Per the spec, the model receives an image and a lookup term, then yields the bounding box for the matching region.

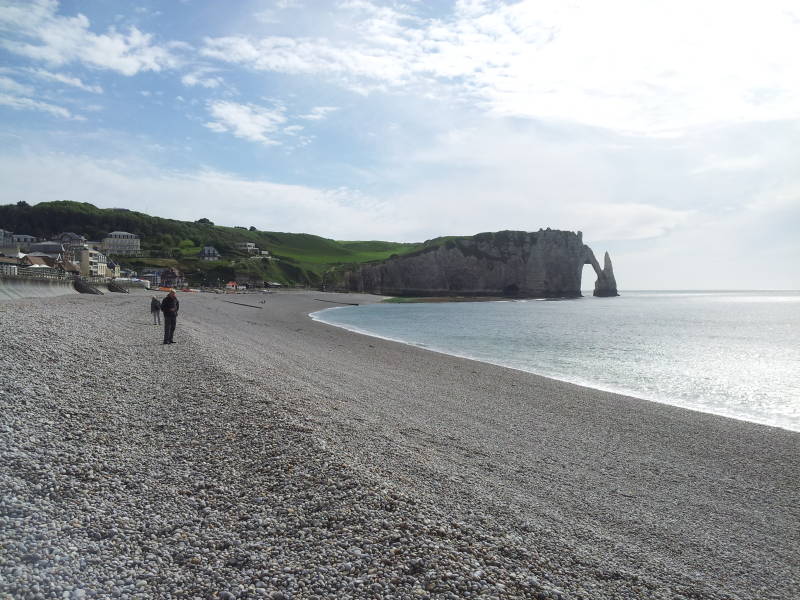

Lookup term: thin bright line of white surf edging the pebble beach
[308,300,800,433]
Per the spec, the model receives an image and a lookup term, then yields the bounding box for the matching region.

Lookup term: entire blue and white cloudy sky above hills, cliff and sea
[0,0,800,291]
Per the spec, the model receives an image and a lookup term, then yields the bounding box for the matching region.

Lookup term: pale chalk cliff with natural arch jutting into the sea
[344,229,617,298]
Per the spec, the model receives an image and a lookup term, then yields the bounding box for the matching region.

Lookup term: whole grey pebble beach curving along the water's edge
[0,292,800,600]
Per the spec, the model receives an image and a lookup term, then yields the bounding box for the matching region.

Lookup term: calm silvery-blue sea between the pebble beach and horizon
[312,292,800,431]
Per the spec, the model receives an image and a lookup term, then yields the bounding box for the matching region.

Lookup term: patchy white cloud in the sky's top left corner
[0,0,178,75]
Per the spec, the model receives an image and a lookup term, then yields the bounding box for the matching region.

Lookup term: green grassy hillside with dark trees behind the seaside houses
[0,200,422,285]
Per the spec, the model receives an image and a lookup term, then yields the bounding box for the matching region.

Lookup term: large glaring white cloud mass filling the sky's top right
[201,0,800,135]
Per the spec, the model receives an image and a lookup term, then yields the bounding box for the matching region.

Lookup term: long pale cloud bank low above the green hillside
[0,153,403,239]
